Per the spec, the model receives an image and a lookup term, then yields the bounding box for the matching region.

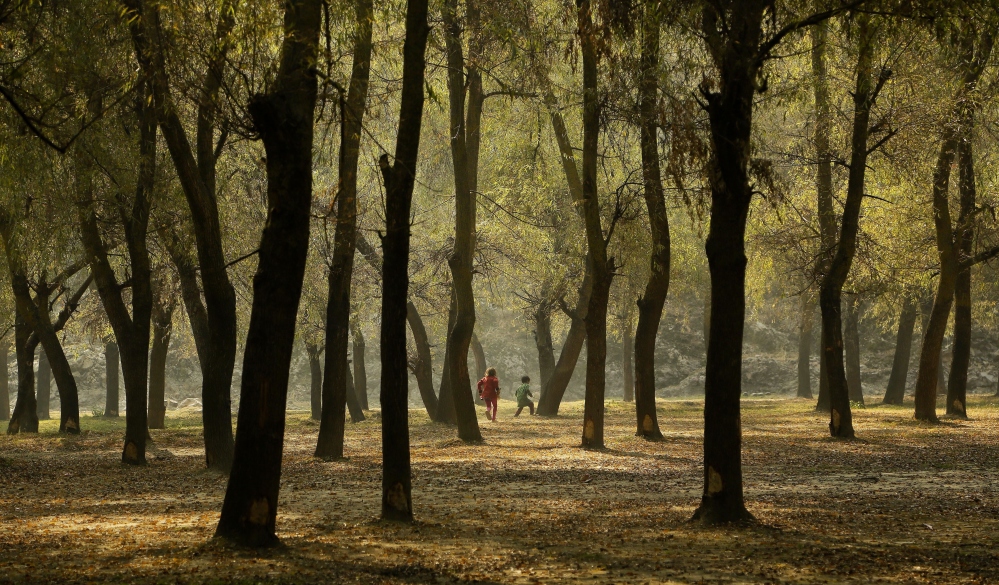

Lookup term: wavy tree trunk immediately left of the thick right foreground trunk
[629,2,672,440]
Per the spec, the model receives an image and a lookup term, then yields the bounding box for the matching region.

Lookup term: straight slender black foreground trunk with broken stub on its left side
[379,0,430,522]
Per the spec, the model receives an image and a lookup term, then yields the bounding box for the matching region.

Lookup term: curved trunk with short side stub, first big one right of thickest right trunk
[819,14,887,438]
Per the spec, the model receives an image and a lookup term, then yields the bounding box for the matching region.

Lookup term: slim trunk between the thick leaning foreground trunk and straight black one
[315,0,374,459]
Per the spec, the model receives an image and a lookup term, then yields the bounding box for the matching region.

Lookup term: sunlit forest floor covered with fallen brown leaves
[0,397,999,583]
